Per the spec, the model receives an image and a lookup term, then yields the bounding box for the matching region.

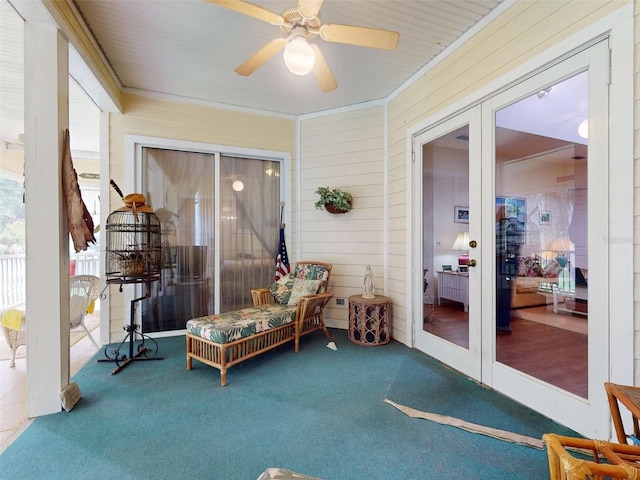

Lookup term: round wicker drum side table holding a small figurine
[349,295,391,347]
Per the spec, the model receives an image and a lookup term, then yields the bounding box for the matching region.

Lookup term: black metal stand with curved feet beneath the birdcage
[98,289,163,375]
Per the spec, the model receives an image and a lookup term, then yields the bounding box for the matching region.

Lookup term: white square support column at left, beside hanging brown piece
[24,19,69,417]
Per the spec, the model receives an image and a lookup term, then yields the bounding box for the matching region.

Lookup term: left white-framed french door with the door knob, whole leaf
[413,107,482,380]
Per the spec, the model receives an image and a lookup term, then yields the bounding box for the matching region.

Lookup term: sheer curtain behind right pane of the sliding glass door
[219,156,280,312]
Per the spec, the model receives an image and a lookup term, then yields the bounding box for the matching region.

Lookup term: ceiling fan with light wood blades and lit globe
[206,0,400,92]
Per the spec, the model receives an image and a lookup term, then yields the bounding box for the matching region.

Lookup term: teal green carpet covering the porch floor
[0,330,575,480]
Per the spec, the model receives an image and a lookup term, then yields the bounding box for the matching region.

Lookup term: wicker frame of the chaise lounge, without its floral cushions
[187,261,333,387]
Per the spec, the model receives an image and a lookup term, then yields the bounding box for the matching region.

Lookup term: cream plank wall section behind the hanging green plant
[298,106,385,328]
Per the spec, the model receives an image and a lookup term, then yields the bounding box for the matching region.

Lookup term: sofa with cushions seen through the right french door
[511,256,562,308]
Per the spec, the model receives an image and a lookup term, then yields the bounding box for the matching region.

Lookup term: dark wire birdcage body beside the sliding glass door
[105,208,162,284]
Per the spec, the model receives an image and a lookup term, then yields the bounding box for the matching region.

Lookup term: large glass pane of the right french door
[495,72,588,398]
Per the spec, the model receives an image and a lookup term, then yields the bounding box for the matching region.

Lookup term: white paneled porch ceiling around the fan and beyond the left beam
[0,0,501,154]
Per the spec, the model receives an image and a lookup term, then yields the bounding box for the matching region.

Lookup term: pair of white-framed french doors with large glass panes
[414,41,609,438]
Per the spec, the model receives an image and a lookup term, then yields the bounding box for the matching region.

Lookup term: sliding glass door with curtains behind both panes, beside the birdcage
[142,147,281,333]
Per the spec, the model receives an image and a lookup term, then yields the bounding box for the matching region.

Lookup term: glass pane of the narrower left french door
[422,126,469,349]
